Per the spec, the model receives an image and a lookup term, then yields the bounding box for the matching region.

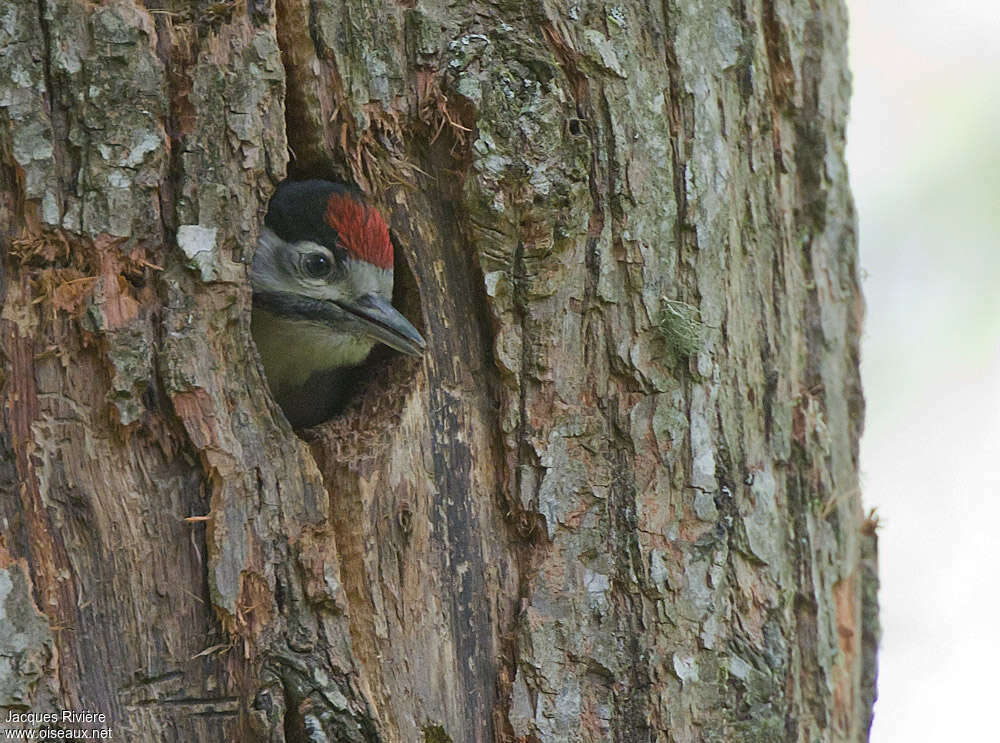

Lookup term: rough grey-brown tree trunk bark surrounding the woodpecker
[0,0,877,743]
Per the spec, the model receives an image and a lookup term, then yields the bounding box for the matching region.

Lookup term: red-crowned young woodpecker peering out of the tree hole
[250,180,426,428]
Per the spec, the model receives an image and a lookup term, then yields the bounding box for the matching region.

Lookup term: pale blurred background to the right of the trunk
[848,0,1000,743]
